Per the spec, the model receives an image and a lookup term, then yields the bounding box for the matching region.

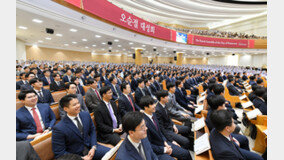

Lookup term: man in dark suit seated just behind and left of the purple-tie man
[85,80,102,113]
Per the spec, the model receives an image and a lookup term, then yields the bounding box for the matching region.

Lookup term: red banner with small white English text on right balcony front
[193,35,248,48]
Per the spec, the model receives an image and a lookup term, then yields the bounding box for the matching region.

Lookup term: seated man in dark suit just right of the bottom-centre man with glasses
[141,96,192,160]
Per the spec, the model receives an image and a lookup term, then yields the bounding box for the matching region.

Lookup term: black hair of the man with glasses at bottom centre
[122,111,144,134]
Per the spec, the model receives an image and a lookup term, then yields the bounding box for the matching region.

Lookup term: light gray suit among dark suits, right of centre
[166,93,192,121]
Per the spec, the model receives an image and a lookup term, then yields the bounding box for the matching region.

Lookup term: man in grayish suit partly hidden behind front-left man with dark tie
[58,82,89,119]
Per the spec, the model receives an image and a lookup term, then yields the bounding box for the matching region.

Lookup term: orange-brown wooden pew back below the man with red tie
[30,132,54,160]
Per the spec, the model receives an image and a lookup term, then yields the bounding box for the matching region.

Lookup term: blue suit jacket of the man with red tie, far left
[16,104,56,141]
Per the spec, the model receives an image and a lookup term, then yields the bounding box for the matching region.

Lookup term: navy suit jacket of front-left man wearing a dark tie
[51,112,98,158]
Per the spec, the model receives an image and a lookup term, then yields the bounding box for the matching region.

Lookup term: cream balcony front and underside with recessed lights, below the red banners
[16,0,267,57]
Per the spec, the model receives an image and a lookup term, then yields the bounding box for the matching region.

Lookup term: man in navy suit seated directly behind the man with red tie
[30,78,54,104]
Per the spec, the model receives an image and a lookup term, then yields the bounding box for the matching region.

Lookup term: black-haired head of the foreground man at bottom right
[209,110,233,132]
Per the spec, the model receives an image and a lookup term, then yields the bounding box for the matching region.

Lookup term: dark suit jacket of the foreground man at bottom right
[209,129,245,160]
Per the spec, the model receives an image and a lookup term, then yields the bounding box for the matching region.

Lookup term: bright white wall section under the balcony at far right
[208,54,267,67]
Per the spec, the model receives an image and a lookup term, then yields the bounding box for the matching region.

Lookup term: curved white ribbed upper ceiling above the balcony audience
[108,0,267,28]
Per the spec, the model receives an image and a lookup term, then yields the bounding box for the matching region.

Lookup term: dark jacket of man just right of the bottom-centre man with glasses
[144,113,167,154]
